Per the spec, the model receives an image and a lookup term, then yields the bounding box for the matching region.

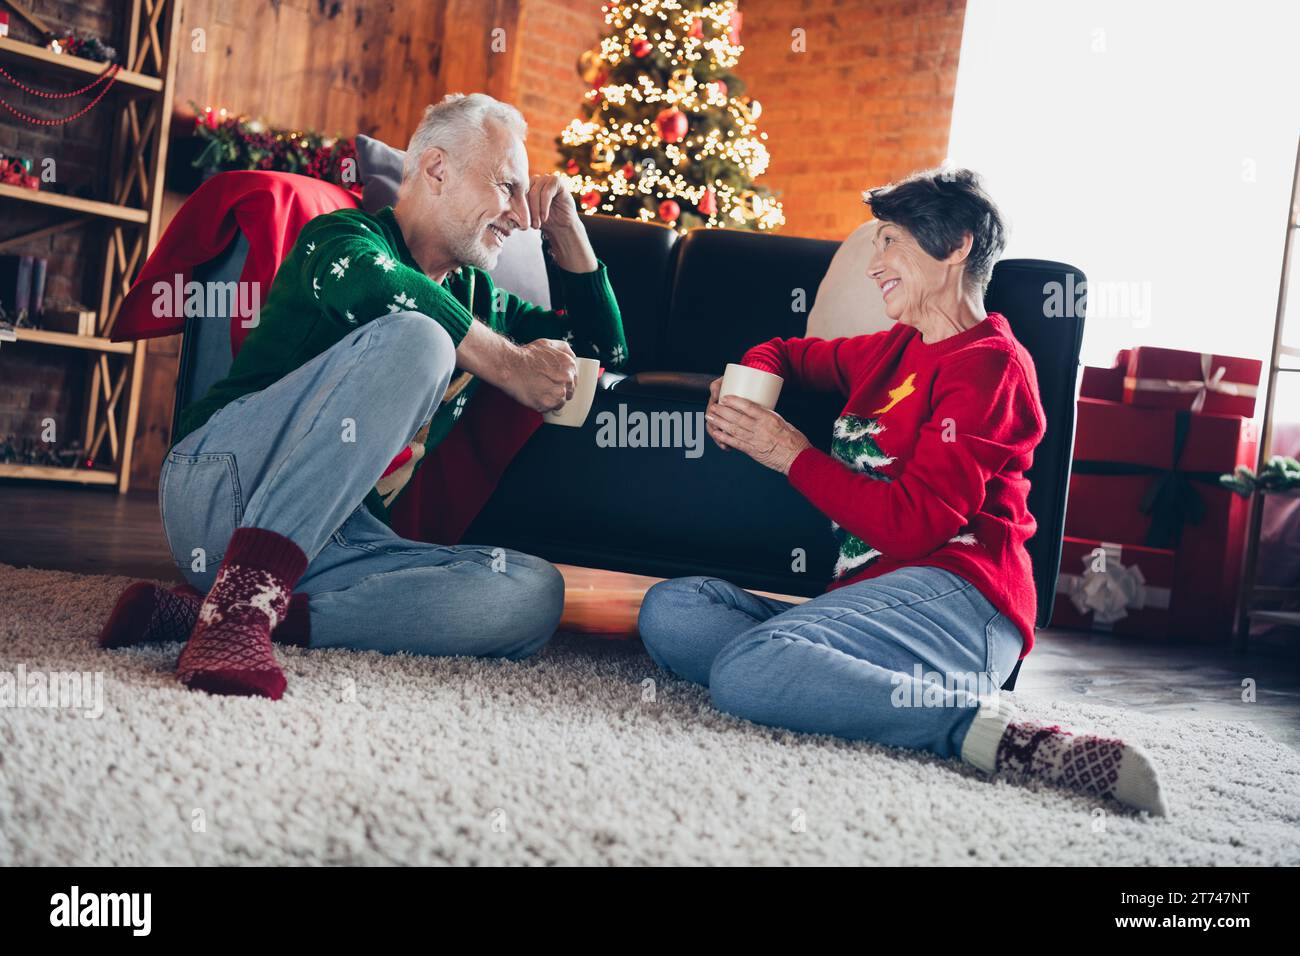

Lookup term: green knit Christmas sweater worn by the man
[172,207,628,522]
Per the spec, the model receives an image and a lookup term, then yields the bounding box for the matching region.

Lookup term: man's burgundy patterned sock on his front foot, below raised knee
[177,528,307,700]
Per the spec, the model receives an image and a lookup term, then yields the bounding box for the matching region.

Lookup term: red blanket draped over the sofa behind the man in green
[113,172,542,544]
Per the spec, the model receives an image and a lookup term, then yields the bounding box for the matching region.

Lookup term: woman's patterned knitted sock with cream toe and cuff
[962,701,1169,817]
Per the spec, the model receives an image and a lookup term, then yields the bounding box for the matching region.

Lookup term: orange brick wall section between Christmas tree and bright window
[737,0,966,239]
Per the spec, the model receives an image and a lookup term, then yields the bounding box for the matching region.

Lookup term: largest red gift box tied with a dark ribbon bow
[1065,398,1258,640]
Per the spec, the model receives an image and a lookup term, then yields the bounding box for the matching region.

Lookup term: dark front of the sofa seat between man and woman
[464,376,844,597]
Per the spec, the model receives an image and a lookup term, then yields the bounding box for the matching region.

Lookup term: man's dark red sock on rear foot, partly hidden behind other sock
[99,581,311,649]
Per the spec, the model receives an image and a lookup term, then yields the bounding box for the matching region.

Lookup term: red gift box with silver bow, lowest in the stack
[1052,537,1174,636]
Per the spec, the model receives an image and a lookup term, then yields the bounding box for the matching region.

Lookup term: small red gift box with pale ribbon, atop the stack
[1125,346,1264,418]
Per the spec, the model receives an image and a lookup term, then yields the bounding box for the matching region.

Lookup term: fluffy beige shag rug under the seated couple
[0,564,1300,866]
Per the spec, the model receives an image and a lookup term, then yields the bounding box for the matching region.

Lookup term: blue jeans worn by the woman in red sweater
[638,567,1024,757]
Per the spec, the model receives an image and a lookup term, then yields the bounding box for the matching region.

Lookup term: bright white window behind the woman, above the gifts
[949,0,1300,392]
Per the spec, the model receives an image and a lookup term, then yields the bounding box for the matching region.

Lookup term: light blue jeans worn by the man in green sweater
[159,312,564,659]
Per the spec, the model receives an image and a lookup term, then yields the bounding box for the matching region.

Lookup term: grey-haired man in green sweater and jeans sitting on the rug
[100,94,627,698]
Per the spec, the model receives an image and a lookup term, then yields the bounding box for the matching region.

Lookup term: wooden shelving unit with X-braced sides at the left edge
[0,0,182,492]
